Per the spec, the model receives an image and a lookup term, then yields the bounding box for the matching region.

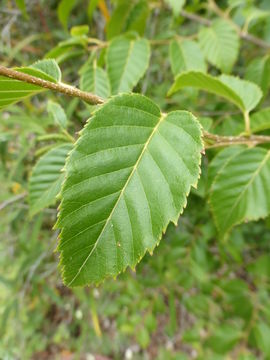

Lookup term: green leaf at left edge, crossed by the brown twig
[0,60,61,110]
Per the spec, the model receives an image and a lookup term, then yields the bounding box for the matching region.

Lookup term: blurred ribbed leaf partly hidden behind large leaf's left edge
[29,144,72,216]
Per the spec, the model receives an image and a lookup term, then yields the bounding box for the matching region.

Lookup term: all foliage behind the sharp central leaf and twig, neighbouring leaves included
[0,0,270,360]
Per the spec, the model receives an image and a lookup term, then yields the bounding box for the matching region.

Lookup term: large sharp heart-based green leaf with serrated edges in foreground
[56,94,202,286]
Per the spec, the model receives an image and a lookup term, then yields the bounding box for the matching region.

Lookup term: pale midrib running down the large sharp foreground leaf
[67,114,166,286]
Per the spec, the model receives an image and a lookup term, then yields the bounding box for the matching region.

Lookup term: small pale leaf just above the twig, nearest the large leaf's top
[80,62,111,99]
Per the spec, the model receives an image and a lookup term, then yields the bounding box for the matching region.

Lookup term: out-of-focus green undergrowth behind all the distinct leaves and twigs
[0,0,270,360]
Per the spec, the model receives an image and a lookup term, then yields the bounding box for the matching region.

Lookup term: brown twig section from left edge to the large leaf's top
[0,65,104,105]
